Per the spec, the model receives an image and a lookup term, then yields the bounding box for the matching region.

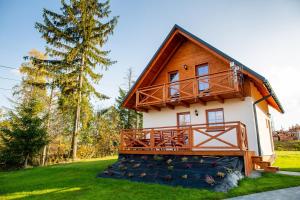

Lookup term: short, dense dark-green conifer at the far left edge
[0,98,48,168]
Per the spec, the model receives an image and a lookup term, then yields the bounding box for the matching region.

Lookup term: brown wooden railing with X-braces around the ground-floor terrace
[120,121,248,151]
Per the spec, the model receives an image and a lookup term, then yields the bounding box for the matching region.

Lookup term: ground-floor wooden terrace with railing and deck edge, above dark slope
[120,121,248,155]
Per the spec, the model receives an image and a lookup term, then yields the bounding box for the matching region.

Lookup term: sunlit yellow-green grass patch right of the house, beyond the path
[273,151,300,172]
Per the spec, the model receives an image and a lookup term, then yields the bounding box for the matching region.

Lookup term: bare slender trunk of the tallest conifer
[71,57,84,160]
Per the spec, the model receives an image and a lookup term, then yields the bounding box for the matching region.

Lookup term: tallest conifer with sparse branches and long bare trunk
[36,0,117,159]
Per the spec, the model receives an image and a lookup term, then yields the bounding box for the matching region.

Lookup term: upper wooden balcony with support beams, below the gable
[136,70,243,110]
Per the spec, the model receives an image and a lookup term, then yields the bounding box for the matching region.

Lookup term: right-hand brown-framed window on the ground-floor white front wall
[206,108,224,129]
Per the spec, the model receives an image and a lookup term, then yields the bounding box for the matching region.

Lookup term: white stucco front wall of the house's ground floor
[143,97,258,152]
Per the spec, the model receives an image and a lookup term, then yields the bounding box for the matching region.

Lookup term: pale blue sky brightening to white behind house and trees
[0,0,300,128]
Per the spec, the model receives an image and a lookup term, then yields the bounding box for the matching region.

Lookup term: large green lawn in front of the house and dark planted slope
[0,154,300,200]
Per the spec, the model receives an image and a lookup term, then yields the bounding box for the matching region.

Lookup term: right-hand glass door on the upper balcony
[196,64,209,93]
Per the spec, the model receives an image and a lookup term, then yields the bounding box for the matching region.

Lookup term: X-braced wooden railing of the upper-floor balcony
[136,70,242,107]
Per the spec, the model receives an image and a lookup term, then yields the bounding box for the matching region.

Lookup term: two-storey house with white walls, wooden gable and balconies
[102,25,284,188]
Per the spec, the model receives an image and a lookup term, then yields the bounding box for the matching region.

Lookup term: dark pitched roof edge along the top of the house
[122,24,284,113]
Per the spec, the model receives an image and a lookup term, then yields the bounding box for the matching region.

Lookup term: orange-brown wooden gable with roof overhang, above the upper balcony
[122,25,284,112]
